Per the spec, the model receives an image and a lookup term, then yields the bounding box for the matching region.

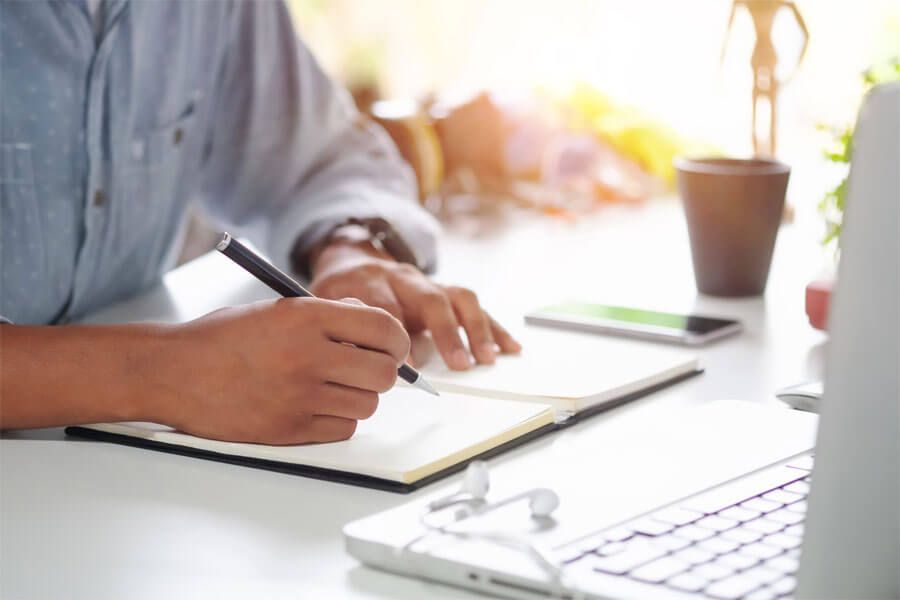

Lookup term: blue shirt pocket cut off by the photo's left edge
[0,144,46,322]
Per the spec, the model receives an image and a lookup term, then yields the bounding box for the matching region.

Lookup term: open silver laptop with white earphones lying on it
[344,83,900,600]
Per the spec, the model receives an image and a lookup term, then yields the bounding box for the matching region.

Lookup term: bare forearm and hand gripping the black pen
[0,298,409,444]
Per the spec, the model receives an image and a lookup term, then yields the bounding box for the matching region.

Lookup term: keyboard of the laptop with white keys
[556,456,812,600]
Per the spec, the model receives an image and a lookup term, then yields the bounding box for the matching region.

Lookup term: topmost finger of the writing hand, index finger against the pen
[317,300,410,366]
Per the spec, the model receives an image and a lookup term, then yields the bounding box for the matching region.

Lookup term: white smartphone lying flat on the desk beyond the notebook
[525,302,741,346]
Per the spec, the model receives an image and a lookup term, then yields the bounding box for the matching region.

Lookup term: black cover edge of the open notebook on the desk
[66,370,703,494]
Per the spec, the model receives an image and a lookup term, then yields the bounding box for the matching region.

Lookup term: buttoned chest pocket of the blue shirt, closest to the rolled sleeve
[118,105,196,284]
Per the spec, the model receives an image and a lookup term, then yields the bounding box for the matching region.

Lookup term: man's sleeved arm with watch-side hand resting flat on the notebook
[197,2,519,369]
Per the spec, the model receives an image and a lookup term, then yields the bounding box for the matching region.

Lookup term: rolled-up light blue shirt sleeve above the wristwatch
[200,0,437,271]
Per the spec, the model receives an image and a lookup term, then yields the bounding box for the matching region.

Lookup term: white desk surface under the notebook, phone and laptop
[0,203,826,600]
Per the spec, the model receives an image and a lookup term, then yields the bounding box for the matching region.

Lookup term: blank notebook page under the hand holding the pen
[89,385,553,483]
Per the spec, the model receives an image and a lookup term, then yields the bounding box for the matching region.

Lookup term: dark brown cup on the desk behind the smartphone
[675,158,791,296]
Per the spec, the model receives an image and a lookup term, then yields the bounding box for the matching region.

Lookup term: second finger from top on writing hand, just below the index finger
[322,343,398,392]
